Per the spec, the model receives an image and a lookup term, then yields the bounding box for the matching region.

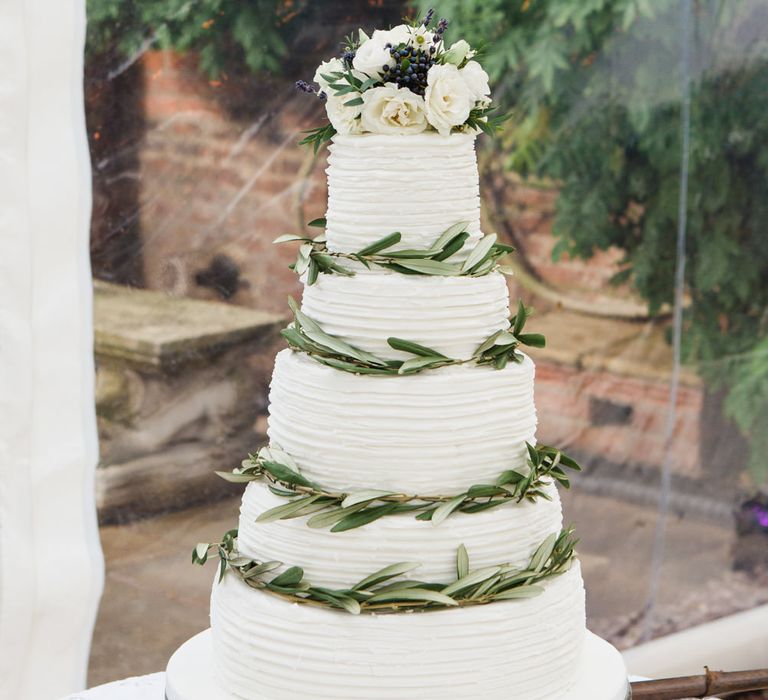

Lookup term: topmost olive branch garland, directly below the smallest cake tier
[273,219,515,285]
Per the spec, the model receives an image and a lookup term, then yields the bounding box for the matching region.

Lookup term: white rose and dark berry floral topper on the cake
[296,10,504,149]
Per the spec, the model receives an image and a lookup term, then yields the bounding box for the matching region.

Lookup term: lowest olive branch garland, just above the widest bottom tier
[192,528,578,615]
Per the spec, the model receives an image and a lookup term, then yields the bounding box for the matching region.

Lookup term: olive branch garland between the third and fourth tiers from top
[216,443,581,532]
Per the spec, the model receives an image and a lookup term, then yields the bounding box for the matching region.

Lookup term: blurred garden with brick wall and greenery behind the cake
[85,0,768,683]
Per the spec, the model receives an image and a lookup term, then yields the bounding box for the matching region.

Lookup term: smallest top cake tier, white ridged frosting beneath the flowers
[326,133,481,253]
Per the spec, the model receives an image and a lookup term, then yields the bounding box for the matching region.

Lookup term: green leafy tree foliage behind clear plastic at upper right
[423,0,768,486]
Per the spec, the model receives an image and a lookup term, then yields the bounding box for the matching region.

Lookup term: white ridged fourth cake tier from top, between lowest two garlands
[238,482,562,588]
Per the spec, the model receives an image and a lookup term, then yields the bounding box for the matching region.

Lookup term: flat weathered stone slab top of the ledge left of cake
[94,282,286,370]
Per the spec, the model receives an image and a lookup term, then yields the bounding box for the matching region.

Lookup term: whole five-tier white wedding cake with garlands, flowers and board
[167,13,628,700]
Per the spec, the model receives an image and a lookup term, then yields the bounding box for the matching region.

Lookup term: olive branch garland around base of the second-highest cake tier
[281,297,546,376]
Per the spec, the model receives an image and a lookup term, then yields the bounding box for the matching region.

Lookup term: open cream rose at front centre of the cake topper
[361,83,427,134]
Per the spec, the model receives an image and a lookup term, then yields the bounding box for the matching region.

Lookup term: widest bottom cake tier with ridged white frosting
[195,562,626,700]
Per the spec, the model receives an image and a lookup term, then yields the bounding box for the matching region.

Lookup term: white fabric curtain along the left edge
[0,0,103,700]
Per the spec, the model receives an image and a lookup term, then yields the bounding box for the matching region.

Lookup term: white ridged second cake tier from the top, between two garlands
[302,272,509,359]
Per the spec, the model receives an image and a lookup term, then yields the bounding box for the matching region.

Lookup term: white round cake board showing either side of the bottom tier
[165,629,629,700]
